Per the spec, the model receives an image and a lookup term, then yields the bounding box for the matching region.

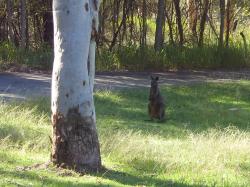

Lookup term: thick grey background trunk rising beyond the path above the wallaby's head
[154,0,166,51]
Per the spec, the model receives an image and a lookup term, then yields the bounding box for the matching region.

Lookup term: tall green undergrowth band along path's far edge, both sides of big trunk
[0,42,250,71]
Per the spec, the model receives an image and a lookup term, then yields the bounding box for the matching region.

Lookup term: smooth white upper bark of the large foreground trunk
[52,0,94,117]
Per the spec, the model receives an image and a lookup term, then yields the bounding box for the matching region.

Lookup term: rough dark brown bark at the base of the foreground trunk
[51,107,101,172]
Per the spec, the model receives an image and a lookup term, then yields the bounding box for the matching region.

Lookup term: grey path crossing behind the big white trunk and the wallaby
[0,71,250,99]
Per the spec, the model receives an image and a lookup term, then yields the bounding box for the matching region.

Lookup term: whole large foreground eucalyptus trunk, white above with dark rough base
[51,0,101,172]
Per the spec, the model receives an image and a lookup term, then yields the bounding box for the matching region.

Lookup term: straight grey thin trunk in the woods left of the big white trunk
[20,0,27,48]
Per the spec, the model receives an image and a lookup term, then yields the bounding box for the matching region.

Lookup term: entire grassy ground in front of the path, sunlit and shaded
[0,80,250,187]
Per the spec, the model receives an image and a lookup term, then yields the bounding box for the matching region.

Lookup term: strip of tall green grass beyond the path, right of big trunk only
[96,45,250,71]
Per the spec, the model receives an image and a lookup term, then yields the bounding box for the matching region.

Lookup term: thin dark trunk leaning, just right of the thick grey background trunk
[174,0,184,46]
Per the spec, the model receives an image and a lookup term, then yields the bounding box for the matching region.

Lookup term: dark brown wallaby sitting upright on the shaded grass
[148,76,165,121]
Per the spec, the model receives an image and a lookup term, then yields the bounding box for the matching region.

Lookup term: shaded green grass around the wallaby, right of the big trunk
[95,83,250,137]
